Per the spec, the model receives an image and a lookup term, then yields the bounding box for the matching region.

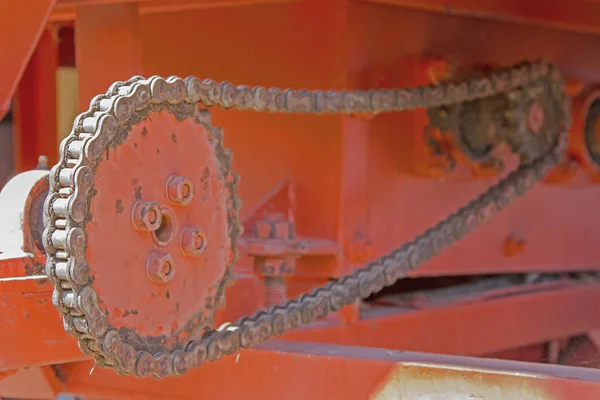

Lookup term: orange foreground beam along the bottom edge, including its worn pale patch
[54,341,600,400]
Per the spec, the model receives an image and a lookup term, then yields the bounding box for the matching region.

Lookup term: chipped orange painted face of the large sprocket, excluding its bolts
[86,111,231,340]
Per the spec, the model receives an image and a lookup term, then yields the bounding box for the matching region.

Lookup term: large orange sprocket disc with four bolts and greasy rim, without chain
[85,107,237,353]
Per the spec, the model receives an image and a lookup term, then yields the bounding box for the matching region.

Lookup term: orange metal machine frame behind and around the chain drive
[0,0,600,399]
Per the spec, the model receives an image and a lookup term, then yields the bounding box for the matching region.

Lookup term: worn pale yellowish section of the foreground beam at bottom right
[369,346,600,400]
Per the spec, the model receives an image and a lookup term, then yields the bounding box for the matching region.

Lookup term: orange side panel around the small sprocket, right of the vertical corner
[360,5,600,276]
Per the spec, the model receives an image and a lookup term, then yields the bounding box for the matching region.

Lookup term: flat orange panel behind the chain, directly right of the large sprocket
[133,2,345,253]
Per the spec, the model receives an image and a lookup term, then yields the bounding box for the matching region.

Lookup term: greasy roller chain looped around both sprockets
[44,61,570,378]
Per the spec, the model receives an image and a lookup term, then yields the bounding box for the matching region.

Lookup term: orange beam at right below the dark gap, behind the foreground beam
[283,283,600,356]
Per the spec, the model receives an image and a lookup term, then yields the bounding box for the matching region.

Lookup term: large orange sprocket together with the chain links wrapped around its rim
[43,77,241,377]
